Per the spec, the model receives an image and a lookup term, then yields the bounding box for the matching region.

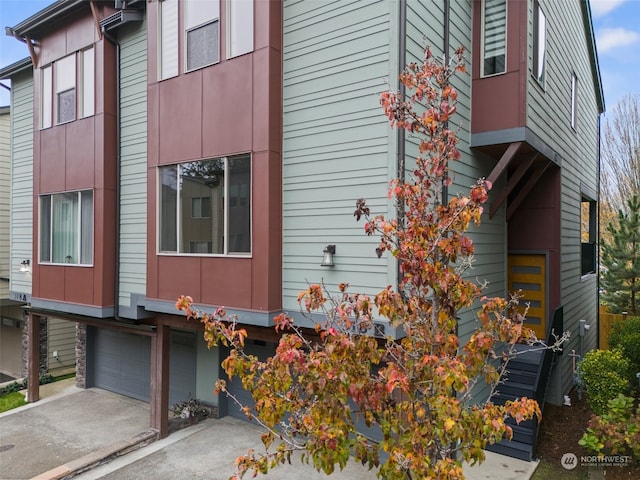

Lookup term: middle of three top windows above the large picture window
[184,0,220,71]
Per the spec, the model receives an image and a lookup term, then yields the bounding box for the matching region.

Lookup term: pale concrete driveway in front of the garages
[0,379,537,480]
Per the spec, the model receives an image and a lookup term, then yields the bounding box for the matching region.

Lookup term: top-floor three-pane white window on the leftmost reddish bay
[40,47,95,128]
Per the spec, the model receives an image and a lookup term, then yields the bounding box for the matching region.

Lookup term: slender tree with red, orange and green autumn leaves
[177,50,540,480]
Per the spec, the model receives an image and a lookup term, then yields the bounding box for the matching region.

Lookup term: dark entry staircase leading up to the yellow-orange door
[487,306,563,461]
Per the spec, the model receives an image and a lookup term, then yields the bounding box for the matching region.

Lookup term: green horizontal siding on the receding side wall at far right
[527,0,598,402]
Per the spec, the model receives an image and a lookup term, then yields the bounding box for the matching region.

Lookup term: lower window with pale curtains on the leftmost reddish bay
[40,190,93,265]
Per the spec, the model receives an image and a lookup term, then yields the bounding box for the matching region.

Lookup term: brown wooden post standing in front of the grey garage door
[150,325,171,438]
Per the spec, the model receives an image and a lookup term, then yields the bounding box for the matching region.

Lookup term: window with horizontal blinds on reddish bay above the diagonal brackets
[482,0,507,76]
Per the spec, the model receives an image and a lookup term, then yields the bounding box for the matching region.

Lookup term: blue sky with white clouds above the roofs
[0,0,640,111]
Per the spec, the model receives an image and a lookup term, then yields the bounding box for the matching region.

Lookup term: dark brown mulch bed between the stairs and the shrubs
[538,390,640,480]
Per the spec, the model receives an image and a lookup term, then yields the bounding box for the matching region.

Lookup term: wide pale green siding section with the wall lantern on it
[282,0,397,311]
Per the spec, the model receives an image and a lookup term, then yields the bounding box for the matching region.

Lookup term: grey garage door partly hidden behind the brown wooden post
[88,328,196,405]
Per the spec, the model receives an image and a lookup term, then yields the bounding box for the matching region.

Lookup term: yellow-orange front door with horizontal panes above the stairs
[507,254,547,340]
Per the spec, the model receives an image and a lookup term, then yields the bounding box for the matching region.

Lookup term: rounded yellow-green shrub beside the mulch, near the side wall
[578,350,631,415]
